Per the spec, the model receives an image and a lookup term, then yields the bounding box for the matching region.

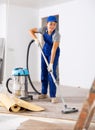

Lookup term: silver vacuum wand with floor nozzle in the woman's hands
[35,39,78,114]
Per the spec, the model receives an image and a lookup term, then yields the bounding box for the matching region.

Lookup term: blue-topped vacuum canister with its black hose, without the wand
[6,40,41,100]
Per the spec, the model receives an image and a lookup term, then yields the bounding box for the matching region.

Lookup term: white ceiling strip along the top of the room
[0,0,72,9]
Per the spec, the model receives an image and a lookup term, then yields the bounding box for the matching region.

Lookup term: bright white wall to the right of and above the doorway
[39,0,95,88]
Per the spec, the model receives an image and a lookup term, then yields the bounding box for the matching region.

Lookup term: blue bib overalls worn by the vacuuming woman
[41,31,60,97]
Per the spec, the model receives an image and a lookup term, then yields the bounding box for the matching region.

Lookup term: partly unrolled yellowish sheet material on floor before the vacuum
[0,94,45,112]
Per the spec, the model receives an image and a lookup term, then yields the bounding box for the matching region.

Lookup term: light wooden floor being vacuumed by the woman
[0,83,95,130]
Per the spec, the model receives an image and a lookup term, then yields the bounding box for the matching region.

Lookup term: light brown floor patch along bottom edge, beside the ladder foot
[17,120,95,130]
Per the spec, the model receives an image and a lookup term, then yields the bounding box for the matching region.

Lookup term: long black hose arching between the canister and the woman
[26,40,41,94]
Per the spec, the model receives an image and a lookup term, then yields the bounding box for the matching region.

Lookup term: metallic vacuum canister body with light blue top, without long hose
[6,68,33,100]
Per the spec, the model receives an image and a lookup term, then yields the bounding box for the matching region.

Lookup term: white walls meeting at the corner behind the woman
[3,0,95,88]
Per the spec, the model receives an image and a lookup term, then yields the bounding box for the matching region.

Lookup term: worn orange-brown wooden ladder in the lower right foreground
[74,79,95,130]
